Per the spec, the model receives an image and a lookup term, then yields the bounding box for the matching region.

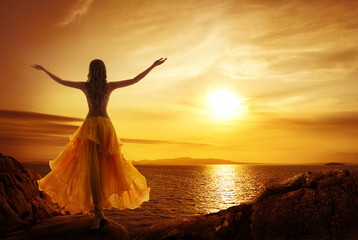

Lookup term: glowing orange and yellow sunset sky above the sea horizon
[0,0,358,164]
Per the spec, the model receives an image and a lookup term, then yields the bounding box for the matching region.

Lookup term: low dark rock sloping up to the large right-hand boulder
[137,204,251,240]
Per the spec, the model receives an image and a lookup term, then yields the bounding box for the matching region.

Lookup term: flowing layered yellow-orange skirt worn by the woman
[37,116,150,213]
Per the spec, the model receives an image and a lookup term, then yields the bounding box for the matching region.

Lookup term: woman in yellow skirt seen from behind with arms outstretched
[32,58,167,229]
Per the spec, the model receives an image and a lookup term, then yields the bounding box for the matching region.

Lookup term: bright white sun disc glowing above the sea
[207,89,245,120]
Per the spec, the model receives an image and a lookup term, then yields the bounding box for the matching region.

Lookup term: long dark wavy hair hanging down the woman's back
[86,59,107,107]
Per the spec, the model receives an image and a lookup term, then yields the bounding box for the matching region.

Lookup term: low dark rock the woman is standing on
[7,215,129,240]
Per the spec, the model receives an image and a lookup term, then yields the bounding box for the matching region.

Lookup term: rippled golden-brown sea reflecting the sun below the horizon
[24,164,358,238]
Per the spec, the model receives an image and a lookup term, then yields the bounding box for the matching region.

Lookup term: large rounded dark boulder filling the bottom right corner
[251,170,358,239]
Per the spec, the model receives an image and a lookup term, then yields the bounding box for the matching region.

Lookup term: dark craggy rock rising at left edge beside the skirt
[0,154,60,236]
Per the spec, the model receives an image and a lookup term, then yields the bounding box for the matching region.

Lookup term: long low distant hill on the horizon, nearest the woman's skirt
[133,157,251,165]
